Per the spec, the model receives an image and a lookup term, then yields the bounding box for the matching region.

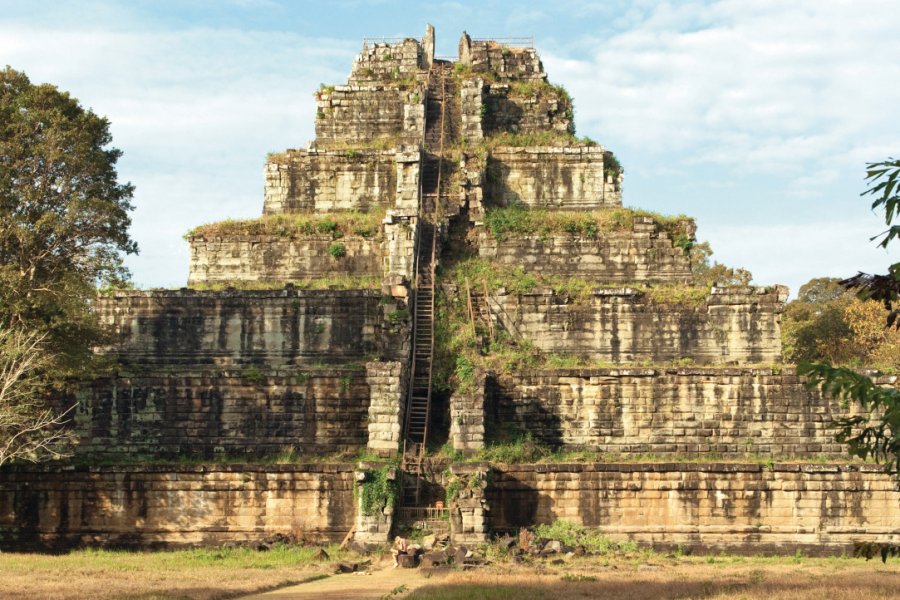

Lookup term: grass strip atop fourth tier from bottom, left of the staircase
[184,211,384,240]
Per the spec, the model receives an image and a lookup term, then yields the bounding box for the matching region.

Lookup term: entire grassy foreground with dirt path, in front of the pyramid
[0,550,900,600]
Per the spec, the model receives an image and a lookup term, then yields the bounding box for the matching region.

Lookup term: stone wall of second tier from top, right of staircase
[482,83,575,135]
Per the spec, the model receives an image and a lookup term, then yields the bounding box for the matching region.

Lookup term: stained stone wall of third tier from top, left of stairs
[263,149,397,215]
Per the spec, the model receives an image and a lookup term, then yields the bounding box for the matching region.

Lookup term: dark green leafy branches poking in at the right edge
[798,158,900,474]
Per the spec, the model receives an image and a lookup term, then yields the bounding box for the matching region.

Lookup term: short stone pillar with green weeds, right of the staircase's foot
[447,463,492,544]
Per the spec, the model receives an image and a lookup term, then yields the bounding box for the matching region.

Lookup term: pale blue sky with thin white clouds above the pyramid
[0,0,900,291]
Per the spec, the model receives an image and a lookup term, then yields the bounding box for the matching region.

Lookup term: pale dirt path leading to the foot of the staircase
[243,568,433,600]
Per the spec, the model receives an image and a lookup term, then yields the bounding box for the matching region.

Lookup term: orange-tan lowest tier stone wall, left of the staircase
[0,464,355,551]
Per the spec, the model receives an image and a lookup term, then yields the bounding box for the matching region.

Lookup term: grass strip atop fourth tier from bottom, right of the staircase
[484,206,693,242]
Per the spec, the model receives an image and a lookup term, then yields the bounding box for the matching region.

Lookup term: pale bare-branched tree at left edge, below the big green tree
[0,327,74,465]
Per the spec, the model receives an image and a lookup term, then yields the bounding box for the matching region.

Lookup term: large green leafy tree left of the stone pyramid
[0,67,137,375]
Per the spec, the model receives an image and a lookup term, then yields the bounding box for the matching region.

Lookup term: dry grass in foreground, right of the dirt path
[406,558,900,600]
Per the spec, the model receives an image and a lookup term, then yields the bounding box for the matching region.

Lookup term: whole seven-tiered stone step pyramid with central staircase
[0,27,900,552]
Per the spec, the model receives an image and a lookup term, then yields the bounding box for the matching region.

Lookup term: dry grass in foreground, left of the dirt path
[0,546,358,600]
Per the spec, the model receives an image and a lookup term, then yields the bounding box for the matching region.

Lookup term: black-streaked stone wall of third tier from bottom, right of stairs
[490,286,787,364]
